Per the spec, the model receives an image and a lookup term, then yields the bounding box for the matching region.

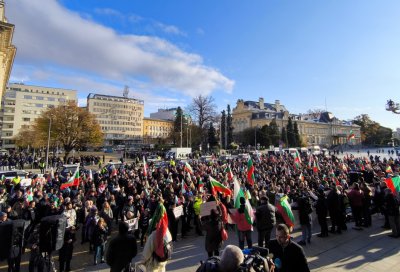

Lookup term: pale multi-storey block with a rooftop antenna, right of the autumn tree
[87,93,144,145]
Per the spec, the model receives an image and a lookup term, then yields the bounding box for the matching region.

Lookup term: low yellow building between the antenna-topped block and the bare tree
[143,117,174,143]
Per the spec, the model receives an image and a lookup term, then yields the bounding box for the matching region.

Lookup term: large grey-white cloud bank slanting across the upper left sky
[6,0,234,97]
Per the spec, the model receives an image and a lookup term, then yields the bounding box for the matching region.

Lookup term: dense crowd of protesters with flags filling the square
[0,149,400,272]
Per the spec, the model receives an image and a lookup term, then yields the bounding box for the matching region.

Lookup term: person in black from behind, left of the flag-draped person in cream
[106,222,137,272]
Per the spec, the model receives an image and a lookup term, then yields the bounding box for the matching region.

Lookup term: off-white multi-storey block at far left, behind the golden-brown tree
[0,84,77,148]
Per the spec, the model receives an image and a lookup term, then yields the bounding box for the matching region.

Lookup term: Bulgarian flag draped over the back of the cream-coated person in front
[147,203,168,258]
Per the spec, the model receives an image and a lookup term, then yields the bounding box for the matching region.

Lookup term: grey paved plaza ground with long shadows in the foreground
[0,212,400,272]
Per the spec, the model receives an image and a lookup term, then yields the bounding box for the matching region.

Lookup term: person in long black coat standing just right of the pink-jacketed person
[256,196,276,247]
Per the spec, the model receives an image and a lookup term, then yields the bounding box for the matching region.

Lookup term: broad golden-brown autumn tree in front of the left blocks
[17,101,103,160]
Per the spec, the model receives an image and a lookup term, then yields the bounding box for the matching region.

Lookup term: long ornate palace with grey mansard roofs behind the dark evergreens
[232,98,361,147]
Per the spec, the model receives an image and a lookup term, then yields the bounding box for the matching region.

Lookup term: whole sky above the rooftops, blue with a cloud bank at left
[5,0,400,129]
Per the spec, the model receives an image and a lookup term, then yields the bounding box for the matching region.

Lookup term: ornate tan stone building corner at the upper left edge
[0,0,17,104]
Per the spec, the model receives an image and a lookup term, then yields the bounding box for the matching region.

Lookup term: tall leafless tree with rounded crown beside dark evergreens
[189,95,216,128]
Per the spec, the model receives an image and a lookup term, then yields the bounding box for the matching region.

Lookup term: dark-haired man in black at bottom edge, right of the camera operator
[268,224,310,272]
